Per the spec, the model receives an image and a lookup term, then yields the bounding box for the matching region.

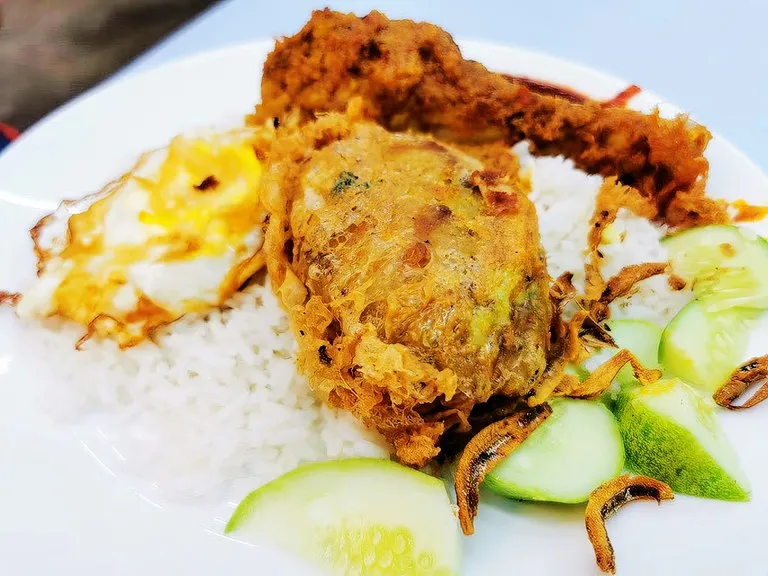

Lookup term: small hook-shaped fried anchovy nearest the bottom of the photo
[585,474,674,574]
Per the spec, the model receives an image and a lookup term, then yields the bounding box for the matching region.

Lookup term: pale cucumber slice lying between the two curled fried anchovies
[485,398,624,503]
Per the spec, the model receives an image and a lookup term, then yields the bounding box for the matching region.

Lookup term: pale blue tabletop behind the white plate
[126,0,768,170]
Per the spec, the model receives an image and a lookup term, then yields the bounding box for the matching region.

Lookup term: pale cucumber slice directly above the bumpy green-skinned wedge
[659,300,760,393]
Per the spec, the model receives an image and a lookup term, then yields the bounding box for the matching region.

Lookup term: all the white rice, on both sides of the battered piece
[28,145,690,508]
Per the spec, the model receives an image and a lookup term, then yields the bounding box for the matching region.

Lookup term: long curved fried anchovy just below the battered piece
[455,404,552,536]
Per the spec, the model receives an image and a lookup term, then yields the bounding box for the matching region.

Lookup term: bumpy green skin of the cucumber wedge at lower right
[615,392,750,502]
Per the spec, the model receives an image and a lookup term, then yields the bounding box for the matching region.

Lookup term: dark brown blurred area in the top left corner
[0,0,220,129]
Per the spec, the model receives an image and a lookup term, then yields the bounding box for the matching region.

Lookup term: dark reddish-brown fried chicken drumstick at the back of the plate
[253,9,728,226]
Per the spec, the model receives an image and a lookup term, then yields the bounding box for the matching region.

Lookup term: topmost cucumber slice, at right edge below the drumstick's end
[663,226,768,311]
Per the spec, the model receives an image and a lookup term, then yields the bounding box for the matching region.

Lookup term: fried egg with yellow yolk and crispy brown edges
[16,128,271,347]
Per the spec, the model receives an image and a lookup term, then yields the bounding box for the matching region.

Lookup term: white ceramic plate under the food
[0,42,768,576]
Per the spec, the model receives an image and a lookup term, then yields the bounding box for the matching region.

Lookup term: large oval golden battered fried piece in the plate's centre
[263,114,553,466]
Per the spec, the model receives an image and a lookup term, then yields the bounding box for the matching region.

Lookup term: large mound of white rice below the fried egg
[37,285,388,500]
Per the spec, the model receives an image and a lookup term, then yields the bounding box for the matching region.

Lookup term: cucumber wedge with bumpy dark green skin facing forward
[616,379,749,501]
